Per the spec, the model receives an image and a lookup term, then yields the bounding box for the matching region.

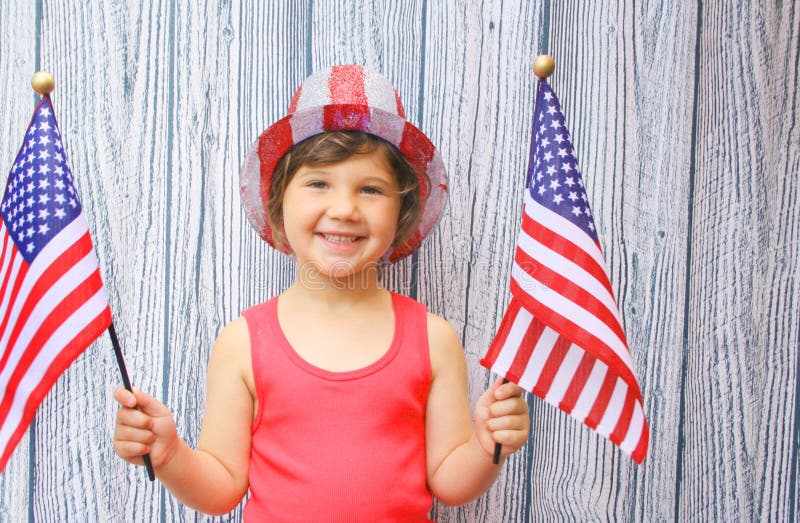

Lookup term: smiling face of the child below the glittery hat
[283,150,401,283]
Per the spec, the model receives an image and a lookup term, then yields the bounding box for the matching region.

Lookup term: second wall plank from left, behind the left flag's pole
[27,2,175,521]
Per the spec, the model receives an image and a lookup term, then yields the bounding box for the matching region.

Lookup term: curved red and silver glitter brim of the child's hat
[239,105,448,262]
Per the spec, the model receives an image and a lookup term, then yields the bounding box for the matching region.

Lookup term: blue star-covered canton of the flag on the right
[527,82,598,246]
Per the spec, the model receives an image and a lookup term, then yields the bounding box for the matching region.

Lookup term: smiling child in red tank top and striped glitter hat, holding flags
[114,66,529,521]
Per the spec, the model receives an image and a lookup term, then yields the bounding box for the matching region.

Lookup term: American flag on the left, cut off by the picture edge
[0,96,111,471]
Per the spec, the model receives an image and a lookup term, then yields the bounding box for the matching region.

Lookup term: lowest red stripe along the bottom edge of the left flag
[0,307,111,470]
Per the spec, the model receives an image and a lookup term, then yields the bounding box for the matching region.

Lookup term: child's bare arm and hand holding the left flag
[114,318,254,514]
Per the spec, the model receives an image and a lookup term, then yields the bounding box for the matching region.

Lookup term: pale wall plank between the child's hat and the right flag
[419,1,542,521]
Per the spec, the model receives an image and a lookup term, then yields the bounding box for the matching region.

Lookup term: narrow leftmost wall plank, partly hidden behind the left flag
[0,2,37,521]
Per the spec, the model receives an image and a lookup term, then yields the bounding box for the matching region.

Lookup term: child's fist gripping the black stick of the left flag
[114,388,180,469]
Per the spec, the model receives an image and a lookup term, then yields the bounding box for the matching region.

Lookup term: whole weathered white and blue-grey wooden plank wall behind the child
[0,0,800,521]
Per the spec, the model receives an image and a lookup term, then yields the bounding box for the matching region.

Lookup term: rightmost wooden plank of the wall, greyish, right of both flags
[679,3,799,520]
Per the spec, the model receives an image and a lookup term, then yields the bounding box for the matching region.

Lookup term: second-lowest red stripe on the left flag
[0,270,103,425]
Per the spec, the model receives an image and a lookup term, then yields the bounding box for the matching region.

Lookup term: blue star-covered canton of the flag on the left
[0,99,81,263]
